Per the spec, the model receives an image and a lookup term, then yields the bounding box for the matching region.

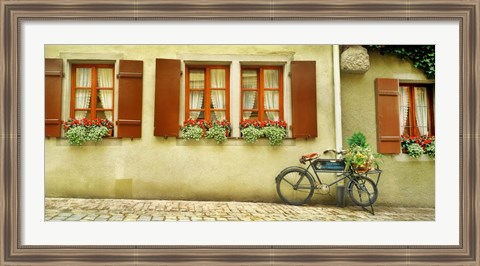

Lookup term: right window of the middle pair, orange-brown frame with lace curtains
[241,66,283,121]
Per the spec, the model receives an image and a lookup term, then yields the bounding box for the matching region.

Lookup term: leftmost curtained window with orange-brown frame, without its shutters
[70,65,114,121]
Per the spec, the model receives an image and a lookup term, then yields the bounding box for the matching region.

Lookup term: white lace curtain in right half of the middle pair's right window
[263,69,280,120]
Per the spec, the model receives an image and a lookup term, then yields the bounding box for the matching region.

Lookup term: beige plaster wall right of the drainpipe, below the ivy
[341,53,435,207]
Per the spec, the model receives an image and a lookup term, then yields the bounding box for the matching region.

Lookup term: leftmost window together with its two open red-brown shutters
[45,59,143,139]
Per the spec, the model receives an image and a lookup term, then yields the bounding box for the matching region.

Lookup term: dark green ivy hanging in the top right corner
[364,45,435,79]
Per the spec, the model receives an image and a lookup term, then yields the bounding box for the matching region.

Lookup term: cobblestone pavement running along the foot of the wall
[45,198,435,221]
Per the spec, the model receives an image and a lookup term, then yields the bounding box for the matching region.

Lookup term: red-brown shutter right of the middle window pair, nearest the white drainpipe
[291,61,317,138]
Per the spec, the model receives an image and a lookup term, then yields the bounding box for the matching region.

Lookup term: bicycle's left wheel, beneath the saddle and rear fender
[277,168,314,205]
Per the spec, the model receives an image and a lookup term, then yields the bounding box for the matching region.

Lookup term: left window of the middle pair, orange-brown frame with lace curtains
[185,66,230,121]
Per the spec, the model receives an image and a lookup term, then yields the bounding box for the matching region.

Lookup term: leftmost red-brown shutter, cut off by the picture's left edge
[45,59,63,137]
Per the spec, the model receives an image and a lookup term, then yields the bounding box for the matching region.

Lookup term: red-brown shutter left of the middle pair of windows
[153,59,181,137]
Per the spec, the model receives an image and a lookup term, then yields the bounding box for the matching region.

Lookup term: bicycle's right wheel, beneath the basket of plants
[347,176,378,207]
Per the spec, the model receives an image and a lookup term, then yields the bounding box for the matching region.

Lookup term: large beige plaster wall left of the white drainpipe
[45,45,335,203]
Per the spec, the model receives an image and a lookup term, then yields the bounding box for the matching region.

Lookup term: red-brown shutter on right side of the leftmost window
[117,60,143,138]
